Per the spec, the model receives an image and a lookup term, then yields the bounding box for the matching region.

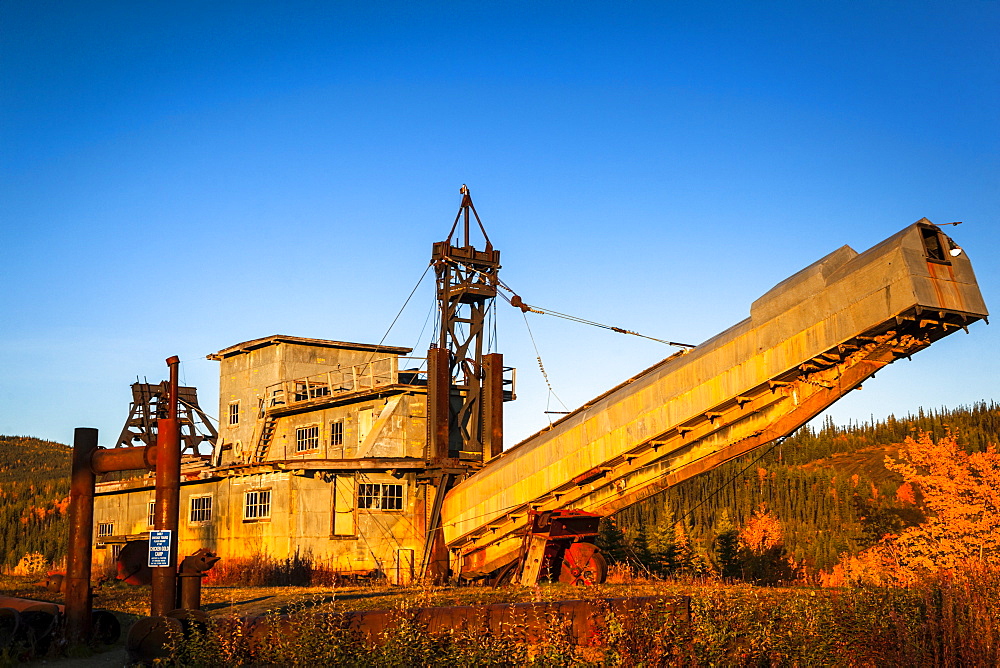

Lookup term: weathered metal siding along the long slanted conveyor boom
[443,221,986,568]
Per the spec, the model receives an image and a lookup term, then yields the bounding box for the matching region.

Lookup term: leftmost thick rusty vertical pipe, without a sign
[65,427,97,645]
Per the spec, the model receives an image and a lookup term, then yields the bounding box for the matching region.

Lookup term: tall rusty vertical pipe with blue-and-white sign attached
[149,356,181,617]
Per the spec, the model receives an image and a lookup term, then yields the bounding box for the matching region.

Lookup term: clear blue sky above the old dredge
[0,0,1000,443]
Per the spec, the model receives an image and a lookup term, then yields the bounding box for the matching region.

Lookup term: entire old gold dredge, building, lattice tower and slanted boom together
[88,188,987,584]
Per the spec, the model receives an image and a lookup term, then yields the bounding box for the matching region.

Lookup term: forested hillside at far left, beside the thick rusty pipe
[0,435,72,569]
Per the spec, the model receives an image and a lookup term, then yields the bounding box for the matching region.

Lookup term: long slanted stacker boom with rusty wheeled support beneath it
[441,219,987,584]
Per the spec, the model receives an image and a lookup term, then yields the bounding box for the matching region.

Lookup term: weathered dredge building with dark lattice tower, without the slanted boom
[94,187,514,584]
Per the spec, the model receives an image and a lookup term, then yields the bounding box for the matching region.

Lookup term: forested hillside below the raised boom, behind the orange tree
[603,402,1000,572]
